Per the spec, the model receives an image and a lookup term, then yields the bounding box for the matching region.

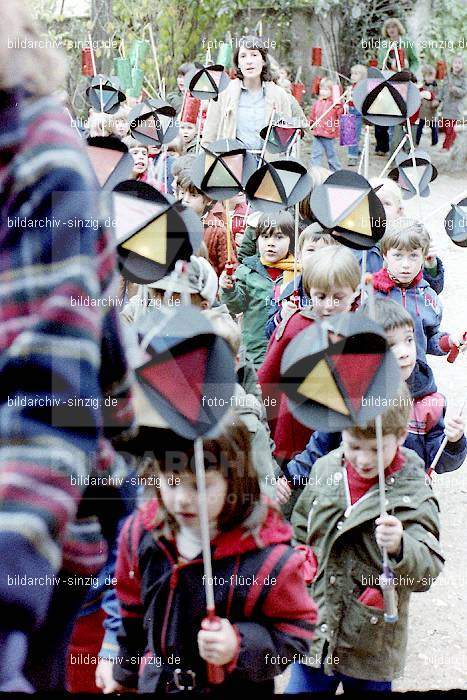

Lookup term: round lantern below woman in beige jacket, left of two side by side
[191,139,256,201]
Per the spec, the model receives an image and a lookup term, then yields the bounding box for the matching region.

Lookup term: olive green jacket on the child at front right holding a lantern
[292,447,444,681]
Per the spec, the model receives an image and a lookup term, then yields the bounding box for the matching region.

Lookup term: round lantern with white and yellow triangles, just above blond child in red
[310,170,386,250]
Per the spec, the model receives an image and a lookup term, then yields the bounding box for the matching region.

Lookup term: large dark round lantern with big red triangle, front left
[131,306,236,440]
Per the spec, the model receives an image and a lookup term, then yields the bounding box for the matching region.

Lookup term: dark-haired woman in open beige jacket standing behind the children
[202,36,307,152]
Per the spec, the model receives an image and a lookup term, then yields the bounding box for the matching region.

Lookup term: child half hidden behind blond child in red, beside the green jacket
[266,224,339,338]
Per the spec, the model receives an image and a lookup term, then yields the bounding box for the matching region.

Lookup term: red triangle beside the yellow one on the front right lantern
[330,353,384,411]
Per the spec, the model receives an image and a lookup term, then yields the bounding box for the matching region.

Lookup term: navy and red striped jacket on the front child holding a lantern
[113,501,316,692]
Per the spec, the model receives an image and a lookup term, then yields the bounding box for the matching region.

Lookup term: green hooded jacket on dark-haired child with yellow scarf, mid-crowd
[220,255,277,369]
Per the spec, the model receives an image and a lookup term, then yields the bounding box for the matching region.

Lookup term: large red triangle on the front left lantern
[138,347,208,423]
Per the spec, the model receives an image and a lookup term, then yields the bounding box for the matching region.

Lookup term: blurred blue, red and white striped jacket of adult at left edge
[0,90,133,629]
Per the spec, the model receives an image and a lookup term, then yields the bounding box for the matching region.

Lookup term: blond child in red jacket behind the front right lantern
[258,246,360,463]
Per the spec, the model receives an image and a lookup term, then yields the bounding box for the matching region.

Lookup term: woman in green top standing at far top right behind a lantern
[375,17,419,156]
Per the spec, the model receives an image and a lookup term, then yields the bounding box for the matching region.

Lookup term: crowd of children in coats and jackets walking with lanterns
[65,37,467,693]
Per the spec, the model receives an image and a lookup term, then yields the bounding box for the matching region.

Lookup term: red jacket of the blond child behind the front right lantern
[258,308,315,460]
